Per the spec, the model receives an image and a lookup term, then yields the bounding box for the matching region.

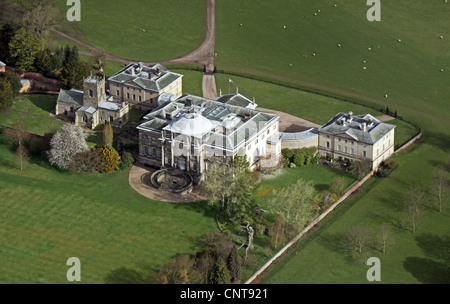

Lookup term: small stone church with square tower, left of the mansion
[56,75,129,129]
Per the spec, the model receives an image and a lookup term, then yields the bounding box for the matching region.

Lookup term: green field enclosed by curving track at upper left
[58,0,206,61]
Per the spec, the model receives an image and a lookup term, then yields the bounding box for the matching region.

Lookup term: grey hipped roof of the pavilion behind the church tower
[108,63,183,92]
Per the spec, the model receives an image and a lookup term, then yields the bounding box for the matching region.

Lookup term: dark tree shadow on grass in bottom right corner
[403,257,450,284]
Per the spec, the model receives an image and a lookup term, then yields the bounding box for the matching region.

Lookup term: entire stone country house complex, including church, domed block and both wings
[56,63,395,181]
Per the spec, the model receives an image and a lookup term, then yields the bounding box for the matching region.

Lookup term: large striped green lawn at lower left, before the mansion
[0,135,216,283]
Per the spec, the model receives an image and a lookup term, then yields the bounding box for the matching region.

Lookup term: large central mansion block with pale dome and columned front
[138,94,281,178]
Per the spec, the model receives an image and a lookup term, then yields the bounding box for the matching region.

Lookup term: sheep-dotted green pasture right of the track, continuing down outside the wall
[216,0,450,283]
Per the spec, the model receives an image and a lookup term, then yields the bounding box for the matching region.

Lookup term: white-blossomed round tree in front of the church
[48,124,89,169]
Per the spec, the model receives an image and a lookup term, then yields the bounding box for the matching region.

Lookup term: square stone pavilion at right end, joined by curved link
[318,112,395,170]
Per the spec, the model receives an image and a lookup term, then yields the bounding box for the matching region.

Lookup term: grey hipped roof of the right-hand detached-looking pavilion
[319,112,395,144]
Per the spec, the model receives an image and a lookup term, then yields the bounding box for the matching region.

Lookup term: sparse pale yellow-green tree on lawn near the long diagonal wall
[269,179,318,235]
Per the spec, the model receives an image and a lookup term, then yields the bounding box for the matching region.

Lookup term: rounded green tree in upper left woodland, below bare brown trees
[9,28,44,71]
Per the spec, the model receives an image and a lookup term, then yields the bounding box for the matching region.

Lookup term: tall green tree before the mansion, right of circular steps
[202,157,254,232]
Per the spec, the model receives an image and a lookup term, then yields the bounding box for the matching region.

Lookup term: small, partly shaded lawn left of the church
[0,95,63,135]
